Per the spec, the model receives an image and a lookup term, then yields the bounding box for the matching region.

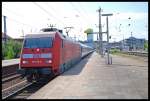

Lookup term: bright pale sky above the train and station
[2,2,148,42]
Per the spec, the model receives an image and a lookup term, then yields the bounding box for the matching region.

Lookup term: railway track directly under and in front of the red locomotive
[2,77,54,99]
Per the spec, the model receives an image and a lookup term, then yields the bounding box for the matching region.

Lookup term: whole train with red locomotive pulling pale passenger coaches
[18,28,92,82]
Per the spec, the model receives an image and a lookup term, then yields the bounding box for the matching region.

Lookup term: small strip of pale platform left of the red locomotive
[2,58,20,67]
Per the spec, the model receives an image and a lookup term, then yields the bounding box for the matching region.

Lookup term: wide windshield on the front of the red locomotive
[24,37,53,48]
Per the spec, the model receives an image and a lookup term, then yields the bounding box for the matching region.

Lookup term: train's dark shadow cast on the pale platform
[61,53,93,76]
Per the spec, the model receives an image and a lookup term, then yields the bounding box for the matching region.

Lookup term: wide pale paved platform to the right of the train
[28,52,148,99]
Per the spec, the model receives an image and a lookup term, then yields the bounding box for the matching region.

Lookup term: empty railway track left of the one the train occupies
[2,64,26,98]
